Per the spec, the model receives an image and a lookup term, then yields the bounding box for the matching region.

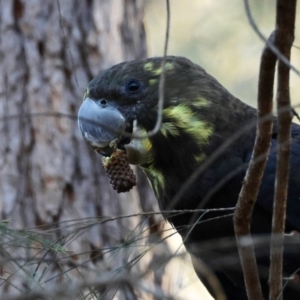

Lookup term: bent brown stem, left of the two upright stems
[234,34,276,300]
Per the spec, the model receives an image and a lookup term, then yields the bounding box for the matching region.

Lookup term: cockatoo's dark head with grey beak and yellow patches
[78,56,254,200]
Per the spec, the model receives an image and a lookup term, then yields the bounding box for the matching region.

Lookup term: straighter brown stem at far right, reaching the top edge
[269,0,297,300]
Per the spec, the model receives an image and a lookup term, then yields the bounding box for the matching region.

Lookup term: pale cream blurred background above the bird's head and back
[145,0,300,110]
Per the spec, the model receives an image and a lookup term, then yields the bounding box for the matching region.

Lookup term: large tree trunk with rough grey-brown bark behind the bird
[0,0,167,299]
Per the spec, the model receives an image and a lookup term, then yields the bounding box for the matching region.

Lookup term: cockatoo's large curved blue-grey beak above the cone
[78,98,126,156]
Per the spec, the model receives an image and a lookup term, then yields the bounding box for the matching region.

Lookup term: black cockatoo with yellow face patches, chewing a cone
[78,56,300,300]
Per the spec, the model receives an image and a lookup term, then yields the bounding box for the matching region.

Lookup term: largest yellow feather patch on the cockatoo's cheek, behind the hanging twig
[163,104,213,148]
